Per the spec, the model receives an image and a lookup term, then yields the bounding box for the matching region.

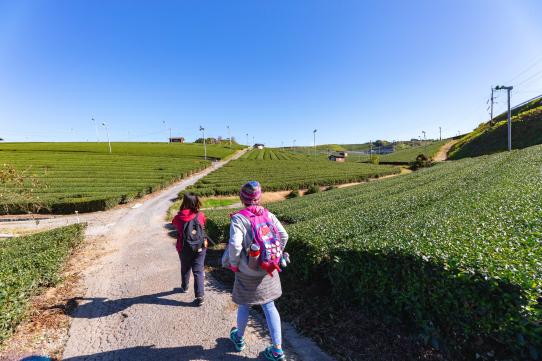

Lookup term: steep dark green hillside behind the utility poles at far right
[449,99,542,159]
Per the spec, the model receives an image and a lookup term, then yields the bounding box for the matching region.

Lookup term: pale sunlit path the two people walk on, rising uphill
[3,148,329,361]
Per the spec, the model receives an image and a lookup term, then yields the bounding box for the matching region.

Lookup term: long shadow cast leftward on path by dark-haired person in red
[51,288,196,318]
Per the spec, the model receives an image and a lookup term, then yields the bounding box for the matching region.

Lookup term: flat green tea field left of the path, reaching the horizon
[0,143,242,213]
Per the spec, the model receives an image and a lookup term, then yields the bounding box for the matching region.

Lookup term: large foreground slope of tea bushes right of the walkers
[207,146,542,360]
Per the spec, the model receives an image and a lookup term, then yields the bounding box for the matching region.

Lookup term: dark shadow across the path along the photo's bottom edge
[64,338,265,361]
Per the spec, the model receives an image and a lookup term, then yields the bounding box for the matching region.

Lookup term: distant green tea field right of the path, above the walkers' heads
[189,149,400,196]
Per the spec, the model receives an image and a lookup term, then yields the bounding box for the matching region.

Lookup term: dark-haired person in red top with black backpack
[171,193,208,306]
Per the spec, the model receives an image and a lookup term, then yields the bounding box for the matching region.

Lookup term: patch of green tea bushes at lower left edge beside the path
[0,224,84,343]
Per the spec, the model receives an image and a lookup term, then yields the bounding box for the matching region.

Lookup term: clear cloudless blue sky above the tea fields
[0,0,542,146]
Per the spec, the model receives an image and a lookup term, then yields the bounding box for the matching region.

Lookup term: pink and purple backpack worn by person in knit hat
[239,209,283,276]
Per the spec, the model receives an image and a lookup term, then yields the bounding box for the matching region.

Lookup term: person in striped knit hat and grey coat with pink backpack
[222,181,288,361]
